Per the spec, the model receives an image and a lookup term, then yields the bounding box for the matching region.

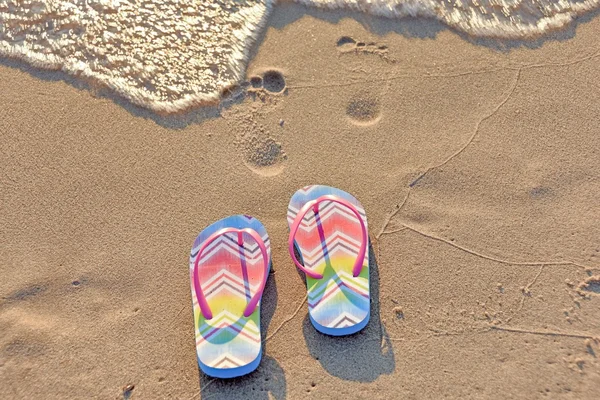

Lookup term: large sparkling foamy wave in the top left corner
[0,0,269,112]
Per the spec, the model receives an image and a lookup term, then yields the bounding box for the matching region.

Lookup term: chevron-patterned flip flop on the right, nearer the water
[287,185,370,336]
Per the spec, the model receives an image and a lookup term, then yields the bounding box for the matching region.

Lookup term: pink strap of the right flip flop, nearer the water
[288,195,369,279]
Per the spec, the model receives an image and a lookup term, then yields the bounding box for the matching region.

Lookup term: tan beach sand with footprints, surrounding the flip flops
[0,4,600,399]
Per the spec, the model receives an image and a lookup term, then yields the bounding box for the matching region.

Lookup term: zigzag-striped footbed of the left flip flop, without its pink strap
[189,215,271,369]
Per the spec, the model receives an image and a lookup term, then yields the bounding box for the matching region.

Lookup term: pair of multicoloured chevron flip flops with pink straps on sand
[190,185,370,378]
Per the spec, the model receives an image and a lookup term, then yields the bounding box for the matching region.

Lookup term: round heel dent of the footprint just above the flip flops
[244,136,287,176]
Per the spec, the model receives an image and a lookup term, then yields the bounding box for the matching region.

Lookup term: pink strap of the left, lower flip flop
[193,228,269,319]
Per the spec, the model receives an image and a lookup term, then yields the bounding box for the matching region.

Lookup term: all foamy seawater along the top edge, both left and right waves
[0,0,600,112]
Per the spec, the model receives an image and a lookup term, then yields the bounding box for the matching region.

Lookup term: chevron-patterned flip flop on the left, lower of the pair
[190,215,271,378]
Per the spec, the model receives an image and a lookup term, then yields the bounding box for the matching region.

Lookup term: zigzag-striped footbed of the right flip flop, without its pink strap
[287,186,370,328]
